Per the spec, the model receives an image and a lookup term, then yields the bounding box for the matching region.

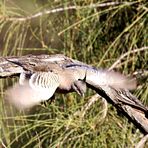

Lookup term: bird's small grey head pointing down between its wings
[72,80,86,96]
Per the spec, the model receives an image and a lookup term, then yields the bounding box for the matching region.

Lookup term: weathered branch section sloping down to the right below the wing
[93,87,148,134]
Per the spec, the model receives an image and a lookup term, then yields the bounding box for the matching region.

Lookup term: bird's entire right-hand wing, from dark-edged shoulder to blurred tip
[65,64,136,90]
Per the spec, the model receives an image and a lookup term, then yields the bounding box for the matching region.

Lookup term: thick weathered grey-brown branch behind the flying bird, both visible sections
[0,55,148,134]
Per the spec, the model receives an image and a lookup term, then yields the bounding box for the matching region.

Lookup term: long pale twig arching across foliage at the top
[6,2,137,21]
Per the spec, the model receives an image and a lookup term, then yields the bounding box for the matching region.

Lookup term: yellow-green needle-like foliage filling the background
[0,0,148,148]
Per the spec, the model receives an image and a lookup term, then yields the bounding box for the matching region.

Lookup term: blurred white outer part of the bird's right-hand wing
[86,69,136,90]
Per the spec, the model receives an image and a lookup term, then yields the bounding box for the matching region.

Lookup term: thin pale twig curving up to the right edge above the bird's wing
[109,46,148,70]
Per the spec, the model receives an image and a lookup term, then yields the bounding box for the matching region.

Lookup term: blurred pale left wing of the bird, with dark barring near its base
[5,72,59,109]
